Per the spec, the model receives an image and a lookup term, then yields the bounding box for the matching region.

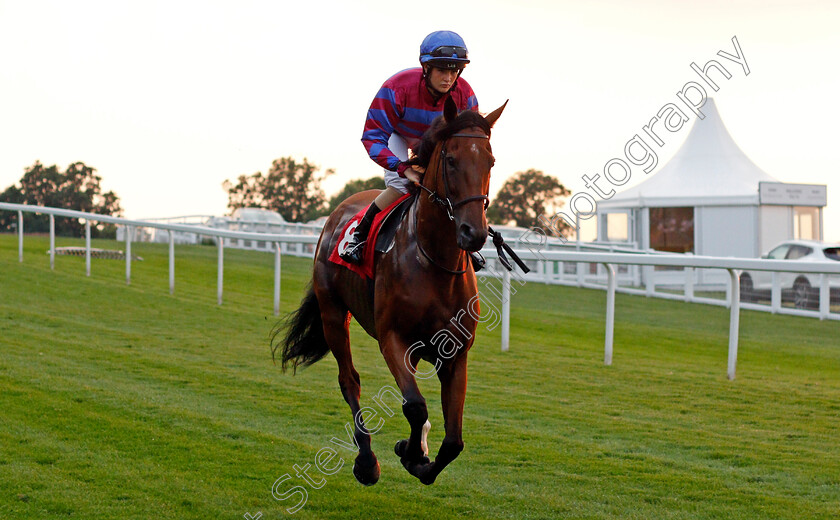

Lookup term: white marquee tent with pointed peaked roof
[596,99,826,257]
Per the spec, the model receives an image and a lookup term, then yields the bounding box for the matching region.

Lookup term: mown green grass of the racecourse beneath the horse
[0,235,840,520]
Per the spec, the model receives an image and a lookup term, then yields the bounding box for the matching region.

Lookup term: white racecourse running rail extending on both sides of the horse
[6,203,840,379]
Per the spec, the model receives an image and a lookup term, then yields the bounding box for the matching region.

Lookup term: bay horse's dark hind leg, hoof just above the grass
[319,298,379,486]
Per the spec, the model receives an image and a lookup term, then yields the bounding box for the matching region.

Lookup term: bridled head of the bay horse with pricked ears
[418,98,507,251]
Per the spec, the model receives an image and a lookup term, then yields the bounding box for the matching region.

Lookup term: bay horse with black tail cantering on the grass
[272,99,507,485]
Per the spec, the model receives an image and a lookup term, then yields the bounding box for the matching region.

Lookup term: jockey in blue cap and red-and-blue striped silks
[340,31,478,264]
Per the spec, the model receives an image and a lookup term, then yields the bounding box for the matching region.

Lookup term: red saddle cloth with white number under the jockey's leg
[330,193,413,278]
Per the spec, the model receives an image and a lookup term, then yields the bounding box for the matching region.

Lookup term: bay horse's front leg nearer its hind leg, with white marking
[380,333,429,474]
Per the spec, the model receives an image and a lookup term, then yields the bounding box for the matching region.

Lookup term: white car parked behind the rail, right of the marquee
[741,240,840,309]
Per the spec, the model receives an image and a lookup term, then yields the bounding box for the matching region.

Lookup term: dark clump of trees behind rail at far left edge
[0,161,122,237]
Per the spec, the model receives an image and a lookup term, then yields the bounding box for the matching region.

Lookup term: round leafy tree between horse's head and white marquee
[487,169,572,235]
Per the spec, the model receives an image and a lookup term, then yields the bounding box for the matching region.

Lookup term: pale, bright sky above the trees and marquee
[0,0,840,241]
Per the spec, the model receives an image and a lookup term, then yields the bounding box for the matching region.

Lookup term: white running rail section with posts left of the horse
[0,202,318,316]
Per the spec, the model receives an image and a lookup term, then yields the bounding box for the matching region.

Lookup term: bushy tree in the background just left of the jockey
[222,157,335,222]
